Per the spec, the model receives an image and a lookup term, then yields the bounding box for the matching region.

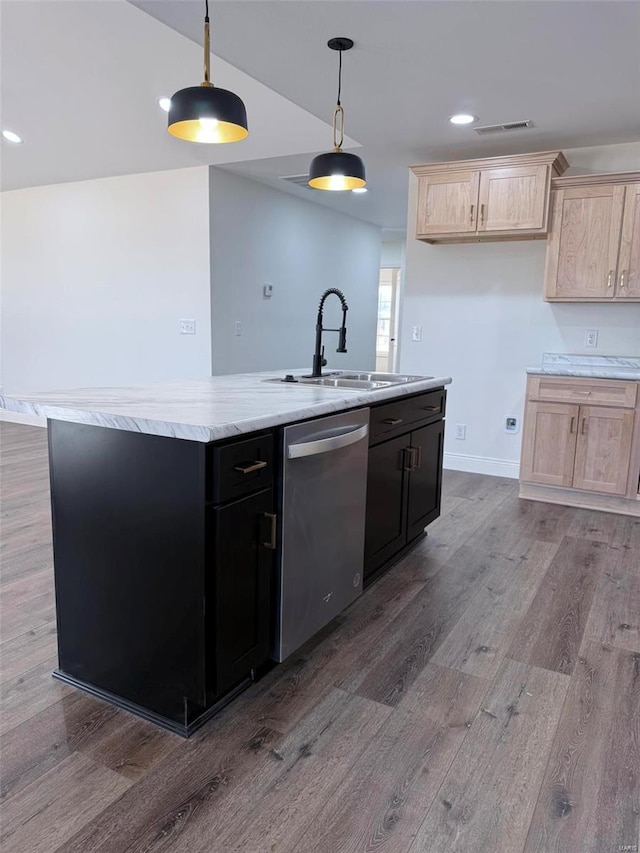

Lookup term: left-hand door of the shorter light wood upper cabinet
[416,172,480,236]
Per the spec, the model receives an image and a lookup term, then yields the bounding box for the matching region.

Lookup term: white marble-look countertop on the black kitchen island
[0,370,451,442]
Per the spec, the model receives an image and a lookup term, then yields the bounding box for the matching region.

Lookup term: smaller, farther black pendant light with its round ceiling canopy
[309,37,367,191]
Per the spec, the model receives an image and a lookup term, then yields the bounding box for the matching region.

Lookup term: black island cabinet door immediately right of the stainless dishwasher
[364,435,410,579]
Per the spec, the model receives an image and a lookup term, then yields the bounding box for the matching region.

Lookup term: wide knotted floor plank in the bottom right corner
[525,642,640,853]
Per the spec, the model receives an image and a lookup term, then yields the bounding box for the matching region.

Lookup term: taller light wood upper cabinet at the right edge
[544,172,640,302]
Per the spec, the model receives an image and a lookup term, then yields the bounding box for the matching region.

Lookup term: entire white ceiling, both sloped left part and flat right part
[0,0,640,229]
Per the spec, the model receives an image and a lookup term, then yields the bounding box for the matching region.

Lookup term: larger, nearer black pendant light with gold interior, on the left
[167,0,249,143]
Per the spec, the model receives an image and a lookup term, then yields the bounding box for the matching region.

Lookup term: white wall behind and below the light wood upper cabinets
[400,136,640,476]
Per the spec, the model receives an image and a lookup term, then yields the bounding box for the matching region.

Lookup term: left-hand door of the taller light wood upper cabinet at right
[545,184,625,301]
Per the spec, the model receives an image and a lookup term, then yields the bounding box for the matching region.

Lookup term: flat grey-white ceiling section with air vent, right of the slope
[132,0,640,229]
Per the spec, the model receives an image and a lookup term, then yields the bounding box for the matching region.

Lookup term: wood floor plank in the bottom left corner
[2,753,131,853]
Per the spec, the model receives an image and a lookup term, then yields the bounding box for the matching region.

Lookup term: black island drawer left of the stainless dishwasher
[208,433,273,503]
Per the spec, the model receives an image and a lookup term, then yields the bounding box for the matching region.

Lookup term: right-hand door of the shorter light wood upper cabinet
[478,165,549,232]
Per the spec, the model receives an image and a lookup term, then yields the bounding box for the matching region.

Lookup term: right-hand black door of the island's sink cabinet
[407,421,444,542]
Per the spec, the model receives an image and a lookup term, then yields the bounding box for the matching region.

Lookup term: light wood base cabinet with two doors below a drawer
[520,376,640,514]
